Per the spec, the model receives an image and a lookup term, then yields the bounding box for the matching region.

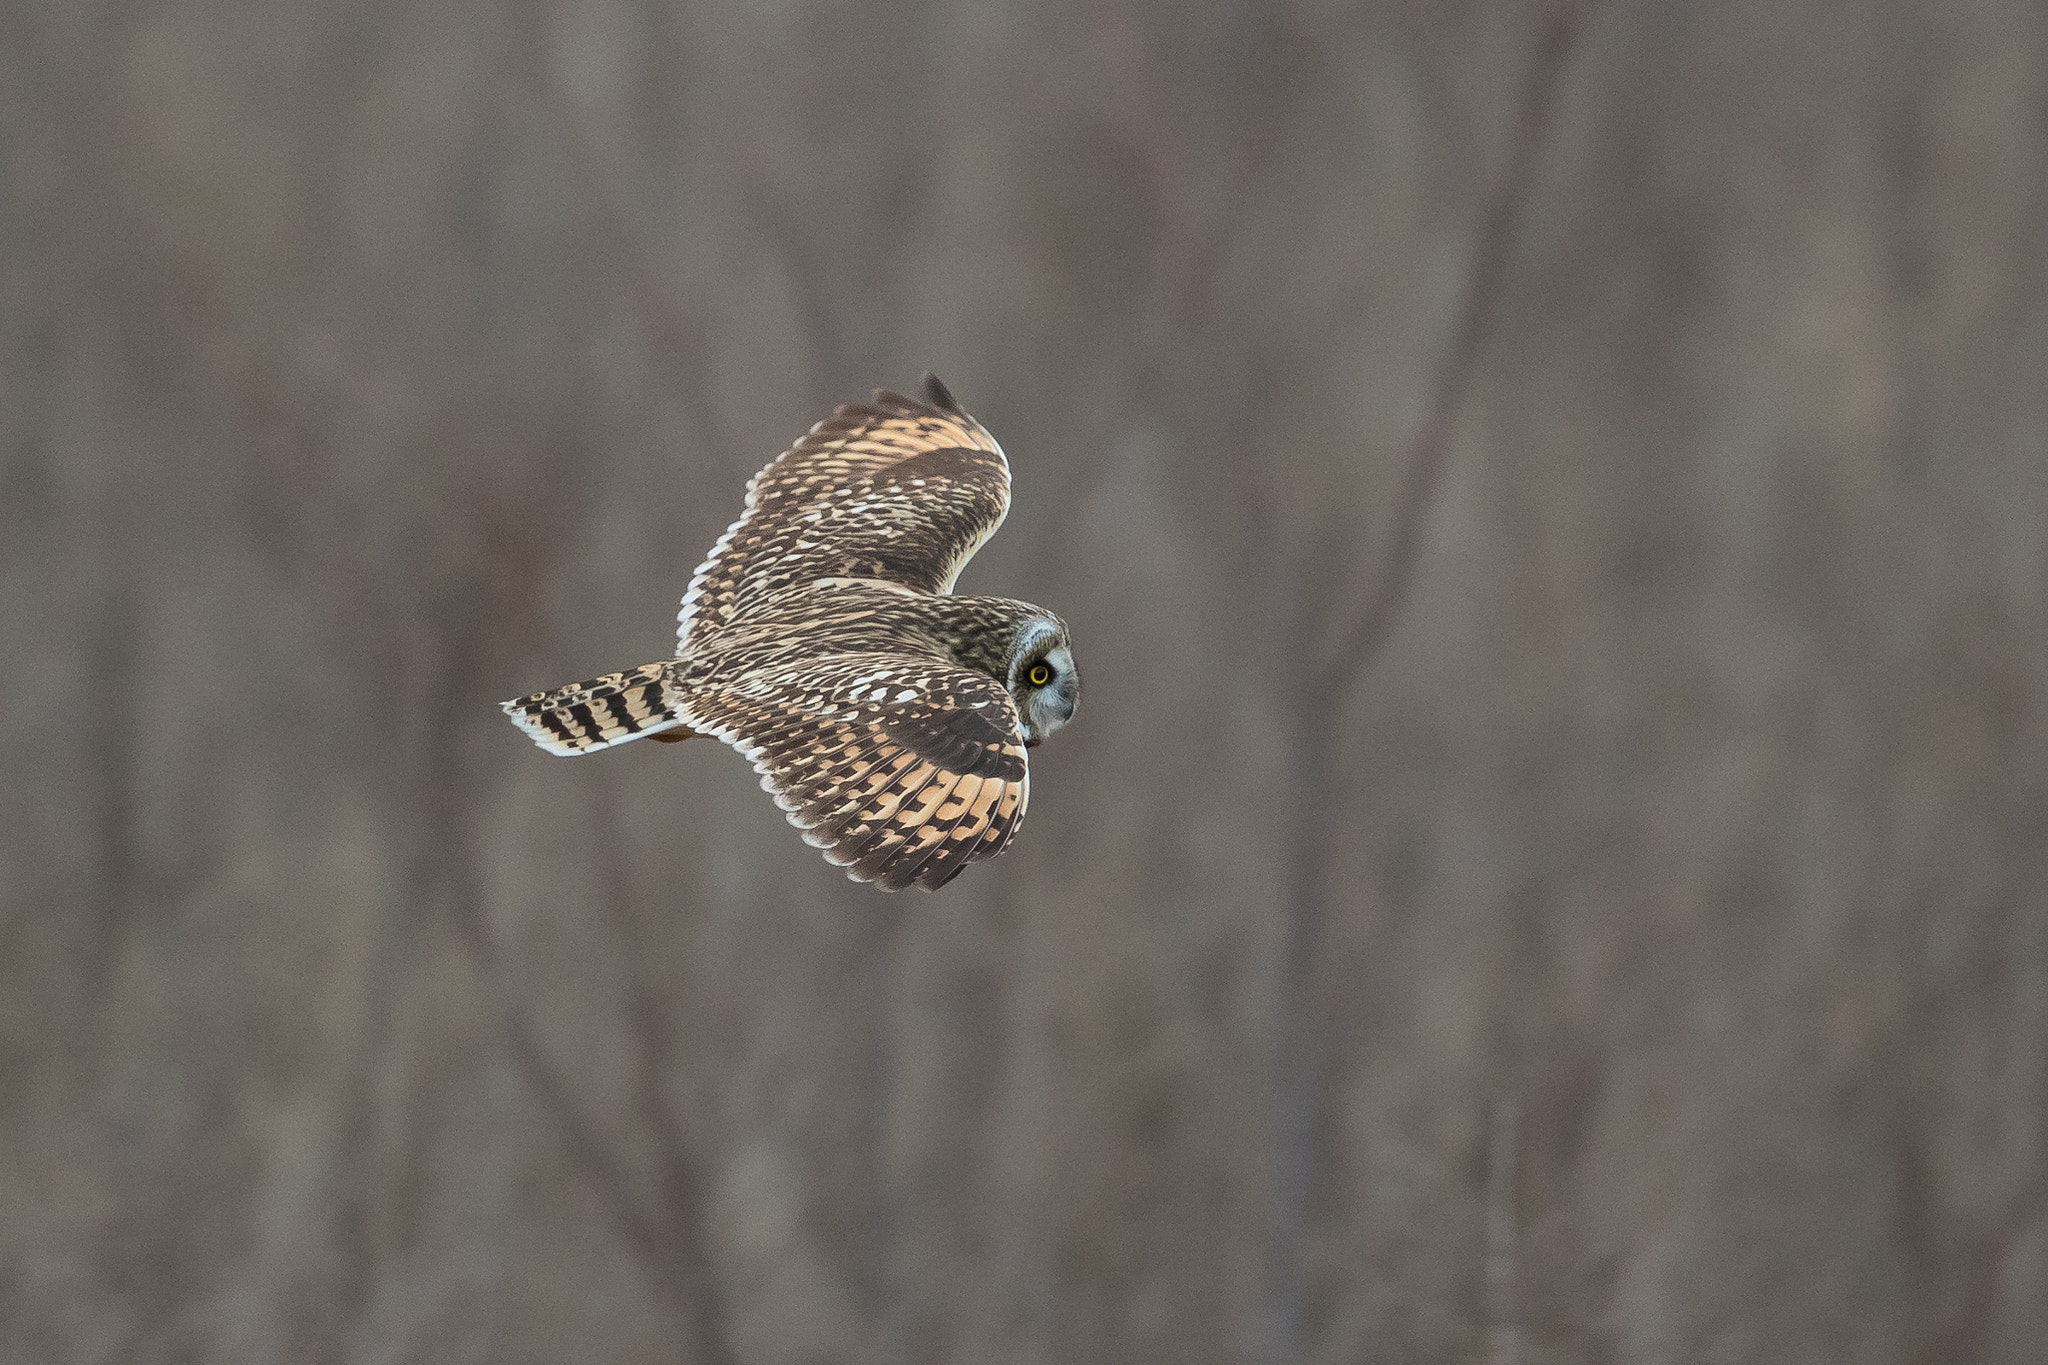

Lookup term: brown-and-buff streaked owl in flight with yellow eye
[504,375,1081,890]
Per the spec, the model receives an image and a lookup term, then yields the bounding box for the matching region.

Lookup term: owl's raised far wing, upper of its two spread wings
[676,375,1010,655]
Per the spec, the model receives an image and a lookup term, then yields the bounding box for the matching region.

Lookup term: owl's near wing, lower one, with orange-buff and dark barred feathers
[684,653,1030,890]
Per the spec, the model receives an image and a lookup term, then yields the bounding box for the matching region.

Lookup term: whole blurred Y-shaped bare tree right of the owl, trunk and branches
[1096,0,1589,1365]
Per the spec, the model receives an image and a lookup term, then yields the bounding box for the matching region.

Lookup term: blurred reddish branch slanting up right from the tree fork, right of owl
[1313,0,1591,692]
